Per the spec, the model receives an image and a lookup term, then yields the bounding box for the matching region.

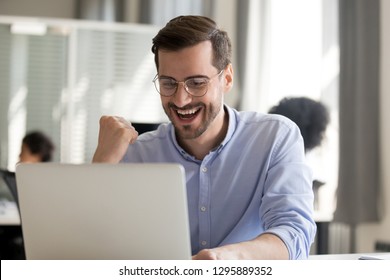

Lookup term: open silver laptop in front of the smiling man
[16,163,191,260]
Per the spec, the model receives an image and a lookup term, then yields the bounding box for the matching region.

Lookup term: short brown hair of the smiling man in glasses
[152,16,232,70]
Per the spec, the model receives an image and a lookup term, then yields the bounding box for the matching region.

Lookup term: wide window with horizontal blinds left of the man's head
[0,17,166,170]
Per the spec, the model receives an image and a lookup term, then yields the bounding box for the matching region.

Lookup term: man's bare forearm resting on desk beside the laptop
[193,234,289,260]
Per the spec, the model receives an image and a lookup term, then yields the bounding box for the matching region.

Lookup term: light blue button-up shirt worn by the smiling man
[122,106,316,259]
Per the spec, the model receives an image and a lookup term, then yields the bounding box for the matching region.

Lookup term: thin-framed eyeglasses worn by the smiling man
[153,70,223,97]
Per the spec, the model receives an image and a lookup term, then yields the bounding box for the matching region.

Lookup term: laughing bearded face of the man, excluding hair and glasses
[158,41,230,139]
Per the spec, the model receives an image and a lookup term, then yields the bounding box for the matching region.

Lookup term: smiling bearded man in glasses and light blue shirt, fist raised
[93,16,316,259]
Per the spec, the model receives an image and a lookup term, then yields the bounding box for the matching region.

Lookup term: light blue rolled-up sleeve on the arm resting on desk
[259,121,316,259]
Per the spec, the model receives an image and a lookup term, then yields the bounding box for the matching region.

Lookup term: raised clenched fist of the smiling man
[92,116,138,163]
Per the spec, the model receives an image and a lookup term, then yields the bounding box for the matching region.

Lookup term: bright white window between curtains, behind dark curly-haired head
[259,0,339,219]
